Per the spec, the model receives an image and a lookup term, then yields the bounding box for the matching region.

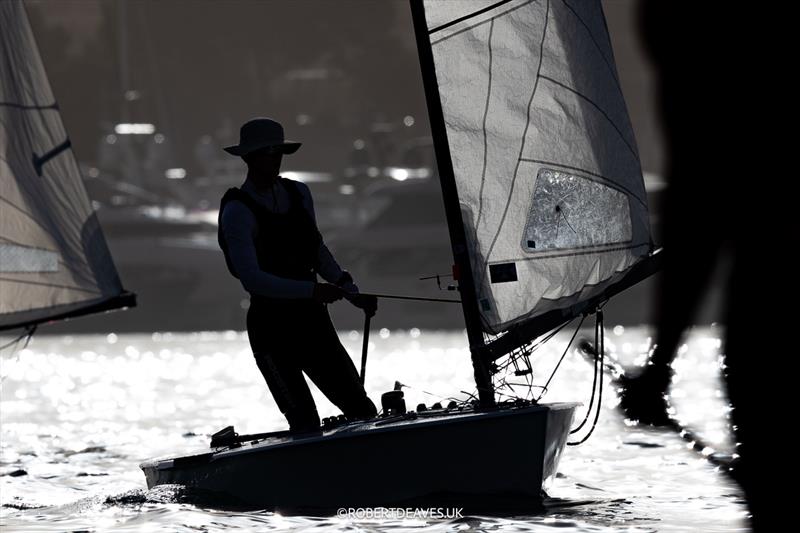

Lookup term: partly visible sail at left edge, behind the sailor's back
[0,0,135,329]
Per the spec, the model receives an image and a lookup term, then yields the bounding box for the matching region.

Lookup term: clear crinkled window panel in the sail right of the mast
[522,168,632,253]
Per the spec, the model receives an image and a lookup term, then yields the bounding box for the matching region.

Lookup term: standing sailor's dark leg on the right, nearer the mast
[304,311,378,419]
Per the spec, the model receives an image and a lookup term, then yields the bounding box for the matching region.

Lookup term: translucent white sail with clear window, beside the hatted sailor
[424,0,651,333]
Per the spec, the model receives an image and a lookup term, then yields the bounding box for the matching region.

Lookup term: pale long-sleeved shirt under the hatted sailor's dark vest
[220,180,358,298]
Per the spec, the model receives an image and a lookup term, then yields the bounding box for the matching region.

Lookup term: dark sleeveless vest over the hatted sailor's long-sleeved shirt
[217,177,322,301]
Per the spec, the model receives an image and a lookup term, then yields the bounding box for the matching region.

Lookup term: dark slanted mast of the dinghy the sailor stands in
[410,0,495,407]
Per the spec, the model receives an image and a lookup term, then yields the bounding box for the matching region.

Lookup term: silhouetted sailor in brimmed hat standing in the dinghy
[218,118,377,432]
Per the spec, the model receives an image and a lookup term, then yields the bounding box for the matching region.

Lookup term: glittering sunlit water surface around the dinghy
[0,327,745,532]
